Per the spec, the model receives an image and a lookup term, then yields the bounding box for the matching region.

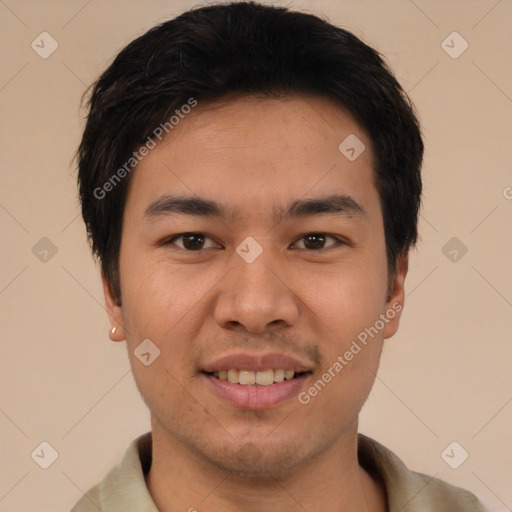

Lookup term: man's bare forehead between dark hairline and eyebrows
[127,97,376,222]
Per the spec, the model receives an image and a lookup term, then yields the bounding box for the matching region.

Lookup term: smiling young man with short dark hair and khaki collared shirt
[73,2,484,512]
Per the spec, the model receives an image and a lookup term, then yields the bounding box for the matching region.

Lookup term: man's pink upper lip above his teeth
[202,352,312,373]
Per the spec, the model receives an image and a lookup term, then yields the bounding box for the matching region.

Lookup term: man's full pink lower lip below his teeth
[202,373,310,410]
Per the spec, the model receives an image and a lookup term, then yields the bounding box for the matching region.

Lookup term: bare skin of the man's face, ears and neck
[103,97,407,512]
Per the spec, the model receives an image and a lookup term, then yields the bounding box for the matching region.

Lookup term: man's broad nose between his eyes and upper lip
[214,249,300,334]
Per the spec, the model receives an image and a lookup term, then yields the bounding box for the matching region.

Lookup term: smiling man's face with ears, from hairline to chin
[105,97,407,476]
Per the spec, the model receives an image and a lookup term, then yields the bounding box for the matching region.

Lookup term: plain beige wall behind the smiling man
[0,0,512,512]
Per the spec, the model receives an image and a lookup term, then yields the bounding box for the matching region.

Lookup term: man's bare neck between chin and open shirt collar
[146,421,386,512]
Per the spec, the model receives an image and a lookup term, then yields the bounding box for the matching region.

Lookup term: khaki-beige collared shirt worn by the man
[71,432,486,512]
